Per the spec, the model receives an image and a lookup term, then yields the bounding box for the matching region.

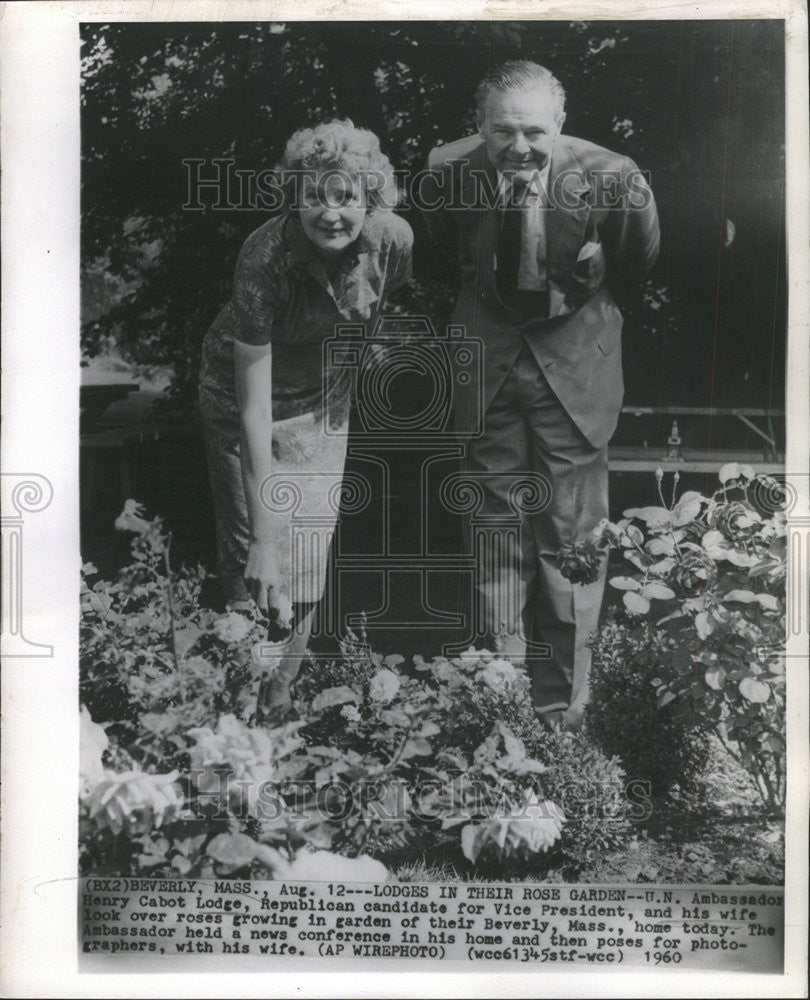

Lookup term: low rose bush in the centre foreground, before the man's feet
[292,637,634,873]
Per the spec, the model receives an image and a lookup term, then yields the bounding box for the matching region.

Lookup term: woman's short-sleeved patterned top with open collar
[200,212,413,429]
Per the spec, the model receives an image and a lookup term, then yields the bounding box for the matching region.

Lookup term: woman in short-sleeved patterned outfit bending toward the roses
[200,121,413,712]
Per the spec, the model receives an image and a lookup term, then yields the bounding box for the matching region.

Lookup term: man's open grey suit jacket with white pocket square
[421,135,659,448]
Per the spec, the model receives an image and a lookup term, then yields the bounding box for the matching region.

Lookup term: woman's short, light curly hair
[277,118,398,212]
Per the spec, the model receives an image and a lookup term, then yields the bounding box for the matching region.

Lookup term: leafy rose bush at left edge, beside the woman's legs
[79,501,263,759]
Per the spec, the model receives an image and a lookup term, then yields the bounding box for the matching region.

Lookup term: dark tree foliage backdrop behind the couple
[82,21,784,404]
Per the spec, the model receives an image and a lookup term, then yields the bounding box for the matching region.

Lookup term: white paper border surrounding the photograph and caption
[0,0,810,997]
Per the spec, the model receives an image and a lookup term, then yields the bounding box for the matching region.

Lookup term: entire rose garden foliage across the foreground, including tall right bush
[80,465,786,880]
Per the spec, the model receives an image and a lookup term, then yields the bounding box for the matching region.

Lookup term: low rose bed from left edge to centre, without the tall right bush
[80,502,624,879]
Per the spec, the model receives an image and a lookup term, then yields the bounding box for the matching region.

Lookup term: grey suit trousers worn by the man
[468,346,608,712]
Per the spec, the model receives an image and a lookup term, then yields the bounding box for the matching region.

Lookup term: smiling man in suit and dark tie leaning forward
[421,61,659,728]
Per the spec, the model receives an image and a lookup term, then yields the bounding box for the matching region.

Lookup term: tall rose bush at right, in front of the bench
[559,463,787,811]
